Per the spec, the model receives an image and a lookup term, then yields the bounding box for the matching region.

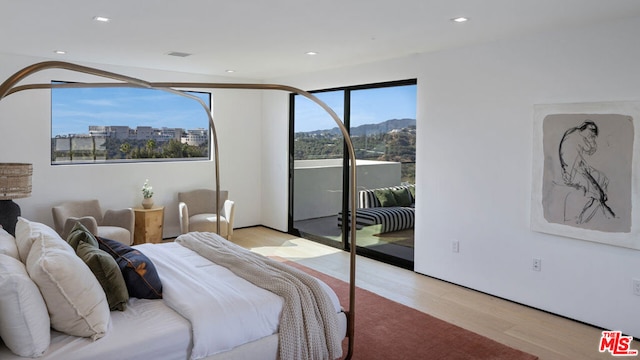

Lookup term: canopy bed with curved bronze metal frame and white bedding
[0,61,356,360]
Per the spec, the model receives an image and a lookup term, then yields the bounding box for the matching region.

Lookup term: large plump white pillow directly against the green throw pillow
[26,233,111,340]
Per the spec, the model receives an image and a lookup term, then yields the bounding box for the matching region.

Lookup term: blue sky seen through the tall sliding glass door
[295,85,416,132]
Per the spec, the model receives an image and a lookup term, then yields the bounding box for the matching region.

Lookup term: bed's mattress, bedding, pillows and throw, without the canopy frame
[0,218,347,359]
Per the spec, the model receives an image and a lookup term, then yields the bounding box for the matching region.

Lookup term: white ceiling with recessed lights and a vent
[0,0,640,79]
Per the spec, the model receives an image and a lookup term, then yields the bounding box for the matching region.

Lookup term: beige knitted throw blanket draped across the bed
[176,232,344,360]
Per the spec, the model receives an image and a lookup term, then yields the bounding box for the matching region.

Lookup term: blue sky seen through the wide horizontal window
[51,88,209,136]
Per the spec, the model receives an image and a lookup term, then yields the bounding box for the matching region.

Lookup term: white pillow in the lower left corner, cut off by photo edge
[0,254,51,357]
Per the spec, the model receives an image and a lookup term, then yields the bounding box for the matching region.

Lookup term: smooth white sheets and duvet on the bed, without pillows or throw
[0,239,346,360]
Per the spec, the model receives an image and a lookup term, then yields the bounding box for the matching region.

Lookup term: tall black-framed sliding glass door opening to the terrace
[290,80,416,268]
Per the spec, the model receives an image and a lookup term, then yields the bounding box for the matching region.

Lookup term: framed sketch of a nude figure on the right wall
[531,102,640,249]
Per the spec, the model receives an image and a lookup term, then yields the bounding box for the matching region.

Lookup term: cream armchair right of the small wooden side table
[178,189,235,240]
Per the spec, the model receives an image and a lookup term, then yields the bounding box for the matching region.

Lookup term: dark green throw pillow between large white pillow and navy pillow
[76,241,129,311]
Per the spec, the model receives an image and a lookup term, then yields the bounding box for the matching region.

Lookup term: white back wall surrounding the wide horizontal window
[0,54,262,237]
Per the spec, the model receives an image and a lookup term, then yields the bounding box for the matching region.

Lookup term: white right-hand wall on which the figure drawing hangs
[263,19,640,338]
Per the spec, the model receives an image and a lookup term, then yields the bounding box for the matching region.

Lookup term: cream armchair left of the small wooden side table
[51,200,135,245]
